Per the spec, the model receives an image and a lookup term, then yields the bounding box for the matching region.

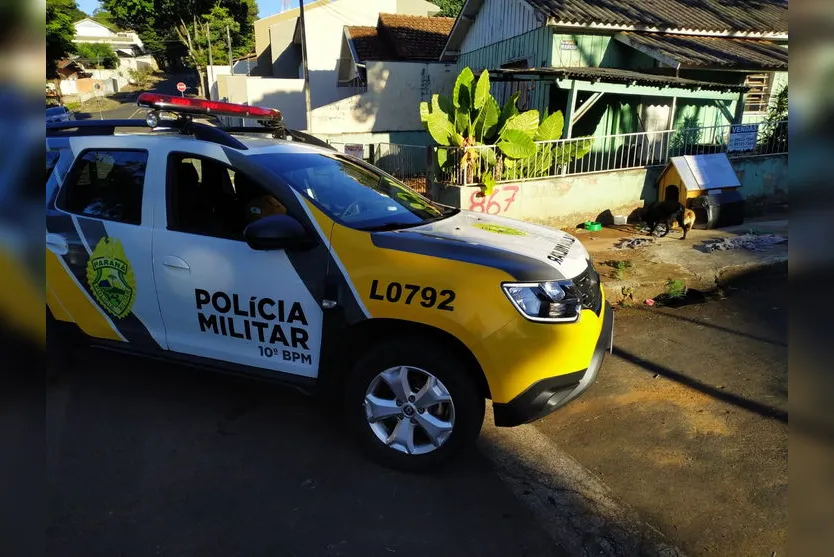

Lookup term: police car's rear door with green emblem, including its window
[46,137,166,351]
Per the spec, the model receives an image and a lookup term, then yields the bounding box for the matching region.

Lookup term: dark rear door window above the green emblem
[58,150,148,224]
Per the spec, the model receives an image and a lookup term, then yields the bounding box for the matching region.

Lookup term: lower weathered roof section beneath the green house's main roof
[617,33,788,70]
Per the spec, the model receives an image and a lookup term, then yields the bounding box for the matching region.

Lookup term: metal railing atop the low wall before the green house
[435,121,788,185]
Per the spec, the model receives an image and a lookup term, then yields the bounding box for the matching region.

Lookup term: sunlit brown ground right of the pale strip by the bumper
[536,266,788,556]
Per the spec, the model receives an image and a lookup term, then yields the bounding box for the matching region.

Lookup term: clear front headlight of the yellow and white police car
[502,280,582,322]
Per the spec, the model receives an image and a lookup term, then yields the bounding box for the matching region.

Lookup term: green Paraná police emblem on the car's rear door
[87,237,136,319]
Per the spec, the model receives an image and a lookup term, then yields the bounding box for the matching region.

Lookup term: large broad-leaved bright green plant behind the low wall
[420,67,590,195]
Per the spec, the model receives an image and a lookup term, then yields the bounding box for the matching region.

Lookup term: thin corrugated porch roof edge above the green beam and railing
[489,68,749,92]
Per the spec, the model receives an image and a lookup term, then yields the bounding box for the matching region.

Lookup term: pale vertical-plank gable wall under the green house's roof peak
[461,0,544,53]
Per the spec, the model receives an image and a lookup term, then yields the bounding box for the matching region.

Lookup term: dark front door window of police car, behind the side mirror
[168,153,287,240]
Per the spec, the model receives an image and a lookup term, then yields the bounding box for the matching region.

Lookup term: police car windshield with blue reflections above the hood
[253,153,458,230]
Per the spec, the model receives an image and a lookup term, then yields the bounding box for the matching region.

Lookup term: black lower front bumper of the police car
[492,302,614,427]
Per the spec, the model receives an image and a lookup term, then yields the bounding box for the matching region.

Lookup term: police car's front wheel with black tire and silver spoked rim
[344,339,485,473]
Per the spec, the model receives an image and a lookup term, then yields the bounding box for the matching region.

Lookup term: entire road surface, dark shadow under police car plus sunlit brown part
[35,272,787,557]
